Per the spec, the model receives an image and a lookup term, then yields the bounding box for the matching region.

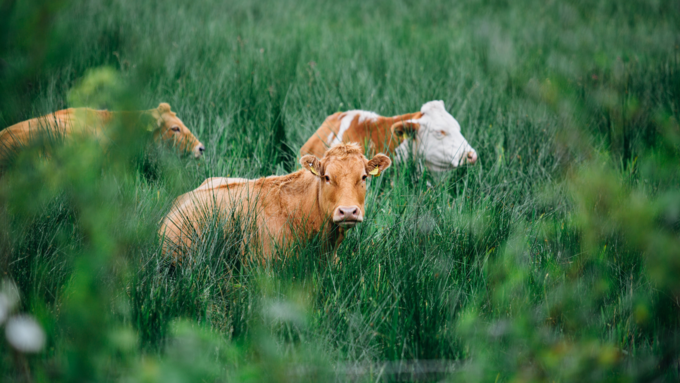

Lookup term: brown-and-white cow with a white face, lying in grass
[300,101,477,173]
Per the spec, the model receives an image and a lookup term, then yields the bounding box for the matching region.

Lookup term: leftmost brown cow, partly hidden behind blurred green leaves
[0,103,205,163]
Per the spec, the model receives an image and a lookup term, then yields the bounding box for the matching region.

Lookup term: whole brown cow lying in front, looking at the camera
[160,143,391,258]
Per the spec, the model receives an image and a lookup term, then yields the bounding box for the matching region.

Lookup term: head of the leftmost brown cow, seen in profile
[151,102,205,158]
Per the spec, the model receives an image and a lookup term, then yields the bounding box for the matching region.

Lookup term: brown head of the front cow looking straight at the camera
[300,143,392,228]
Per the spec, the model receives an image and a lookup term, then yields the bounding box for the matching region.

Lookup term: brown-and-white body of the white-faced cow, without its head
[300,112,423,157]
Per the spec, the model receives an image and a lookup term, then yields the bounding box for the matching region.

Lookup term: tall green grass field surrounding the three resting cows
[0,0,680,382]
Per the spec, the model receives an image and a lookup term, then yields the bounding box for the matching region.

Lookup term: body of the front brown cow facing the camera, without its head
[159,170,321,259]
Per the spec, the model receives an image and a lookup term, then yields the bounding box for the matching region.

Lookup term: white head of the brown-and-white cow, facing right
[391,101,477,173]
